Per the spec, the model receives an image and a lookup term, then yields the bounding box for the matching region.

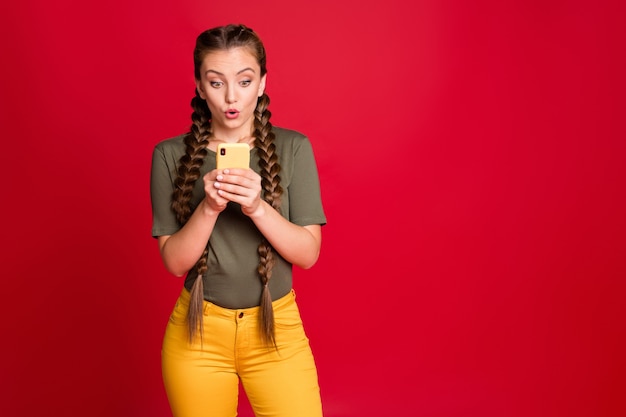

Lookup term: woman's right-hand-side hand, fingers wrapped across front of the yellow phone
[212,168,262,217]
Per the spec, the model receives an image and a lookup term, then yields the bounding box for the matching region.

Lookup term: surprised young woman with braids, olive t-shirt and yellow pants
[150,25,326,417]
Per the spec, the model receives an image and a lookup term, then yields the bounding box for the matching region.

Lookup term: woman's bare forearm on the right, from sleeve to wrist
[250,201,322,269]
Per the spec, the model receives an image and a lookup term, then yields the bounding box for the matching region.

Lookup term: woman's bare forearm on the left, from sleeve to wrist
[159,200,219,277]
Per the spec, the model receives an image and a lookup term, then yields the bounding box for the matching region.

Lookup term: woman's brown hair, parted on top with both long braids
[172,25,283,346]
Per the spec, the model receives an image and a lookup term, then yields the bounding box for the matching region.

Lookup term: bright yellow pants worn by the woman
[162,289,322,417]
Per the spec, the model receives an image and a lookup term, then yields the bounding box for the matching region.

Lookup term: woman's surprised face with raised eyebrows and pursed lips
[196,48,265,141]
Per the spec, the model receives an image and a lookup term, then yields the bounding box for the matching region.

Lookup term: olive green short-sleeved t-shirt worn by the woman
[150,127,326,309]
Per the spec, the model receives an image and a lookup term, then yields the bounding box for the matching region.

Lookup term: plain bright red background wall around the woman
[0,0,626,417]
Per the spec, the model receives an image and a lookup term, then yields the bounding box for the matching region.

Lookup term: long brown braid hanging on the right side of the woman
[253,94,283,346]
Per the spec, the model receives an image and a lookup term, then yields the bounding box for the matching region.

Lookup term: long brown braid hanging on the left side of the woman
[172,90,211,342]
